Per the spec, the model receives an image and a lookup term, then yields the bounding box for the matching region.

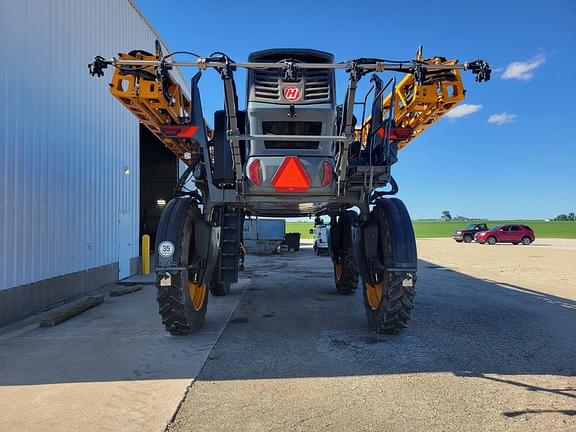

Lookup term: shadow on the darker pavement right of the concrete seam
[199,254,576,384]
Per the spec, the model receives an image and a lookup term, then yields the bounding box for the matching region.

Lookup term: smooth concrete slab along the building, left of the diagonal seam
[0,279,248,432]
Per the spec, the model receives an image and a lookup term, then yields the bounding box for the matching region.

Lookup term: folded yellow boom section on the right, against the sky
[358,57,464,150]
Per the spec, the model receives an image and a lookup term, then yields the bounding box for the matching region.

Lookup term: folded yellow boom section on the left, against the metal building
[110,51,194,162]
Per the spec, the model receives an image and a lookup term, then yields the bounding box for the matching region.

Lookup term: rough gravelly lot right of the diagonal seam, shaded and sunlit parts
[169,239,576,432]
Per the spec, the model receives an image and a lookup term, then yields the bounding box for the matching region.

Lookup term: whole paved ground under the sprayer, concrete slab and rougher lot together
[0,239,576,432]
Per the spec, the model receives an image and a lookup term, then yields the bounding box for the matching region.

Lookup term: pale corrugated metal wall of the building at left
[0,0,184,289]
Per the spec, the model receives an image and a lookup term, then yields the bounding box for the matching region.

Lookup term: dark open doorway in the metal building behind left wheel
[140,124,178,253]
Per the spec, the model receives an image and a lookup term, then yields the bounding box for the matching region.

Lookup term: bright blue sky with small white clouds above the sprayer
[136,0,576,219]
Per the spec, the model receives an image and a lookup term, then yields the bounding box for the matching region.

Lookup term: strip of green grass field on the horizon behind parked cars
[286,220,576,239]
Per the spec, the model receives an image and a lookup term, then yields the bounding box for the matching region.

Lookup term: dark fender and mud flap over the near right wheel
[354,198,418,285]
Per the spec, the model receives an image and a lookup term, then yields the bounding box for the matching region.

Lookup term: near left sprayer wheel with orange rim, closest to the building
[156,198,208,335]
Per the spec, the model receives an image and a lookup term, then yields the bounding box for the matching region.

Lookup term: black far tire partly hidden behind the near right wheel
[330,210,360,295]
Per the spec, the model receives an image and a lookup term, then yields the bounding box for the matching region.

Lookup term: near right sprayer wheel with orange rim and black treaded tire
[363,198,416,334]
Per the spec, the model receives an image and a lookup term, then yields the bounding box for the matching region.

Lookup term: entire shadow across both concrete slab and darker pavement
[0,250,576,386]
